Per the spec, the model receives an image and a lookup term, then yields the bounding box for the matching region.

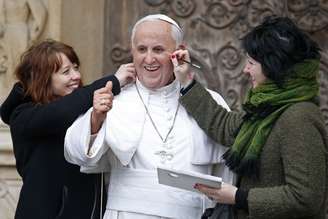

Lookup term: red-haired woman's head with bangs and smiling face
[15,40,82,104]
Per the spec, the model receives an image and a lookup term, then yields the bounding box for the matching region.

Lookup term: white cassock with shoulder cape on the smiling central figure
[65,81,233,219]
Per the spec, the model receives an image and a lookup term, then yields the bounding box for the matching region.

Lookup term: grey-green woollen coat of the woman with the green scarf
[180,83,328,219]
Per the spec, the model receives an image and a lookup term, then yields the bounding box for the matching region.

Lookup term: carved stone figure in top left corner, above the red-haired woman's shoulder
[0,0,47,102]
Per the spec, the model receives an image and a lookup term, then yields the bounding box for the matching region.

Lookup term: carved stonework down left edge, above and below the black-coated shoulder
[0,0,48,219]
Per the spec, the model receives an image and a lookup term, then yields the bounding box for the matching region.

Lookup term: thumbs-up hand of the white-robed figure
[91,81,114,134]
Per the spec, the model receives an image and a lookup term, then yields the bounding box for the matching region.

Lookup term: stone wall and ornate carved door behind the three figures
[0,0,328,219]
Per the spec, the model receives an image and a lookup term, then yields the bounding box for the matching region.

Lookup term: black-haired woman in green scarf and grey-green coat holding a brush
[172,17,328,219]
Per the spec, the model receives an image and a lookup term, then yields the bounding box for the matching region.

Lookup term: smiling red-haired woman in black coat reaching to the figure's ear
[1,40,134,219]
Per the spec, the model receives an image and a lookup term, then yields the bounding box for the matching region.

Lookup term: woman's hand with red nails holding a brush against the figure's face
[171,47,193,87]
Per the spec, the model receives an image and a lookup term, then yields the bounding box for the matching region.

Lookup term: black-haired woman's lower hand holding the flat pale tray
[195,183,237,204]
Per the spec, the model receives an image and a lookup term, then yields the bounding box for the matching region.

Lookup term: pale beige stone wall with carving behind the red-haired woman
[0,0,105,219]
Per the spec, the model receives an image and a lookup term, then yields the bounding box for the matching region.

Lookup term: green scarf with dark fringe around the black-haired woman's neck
[223,59,320,176]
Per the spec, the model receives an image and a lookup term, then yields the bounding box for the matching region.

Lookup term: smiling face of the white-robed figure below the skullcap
[132,20,176,89]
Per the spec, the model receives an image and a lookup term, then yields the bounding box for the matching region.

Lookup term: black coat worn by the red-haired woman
[1,76,120,219]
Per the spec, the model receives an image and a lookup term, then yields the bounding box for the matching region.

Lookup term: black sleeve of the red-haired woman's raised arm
[10,76,120,136]
